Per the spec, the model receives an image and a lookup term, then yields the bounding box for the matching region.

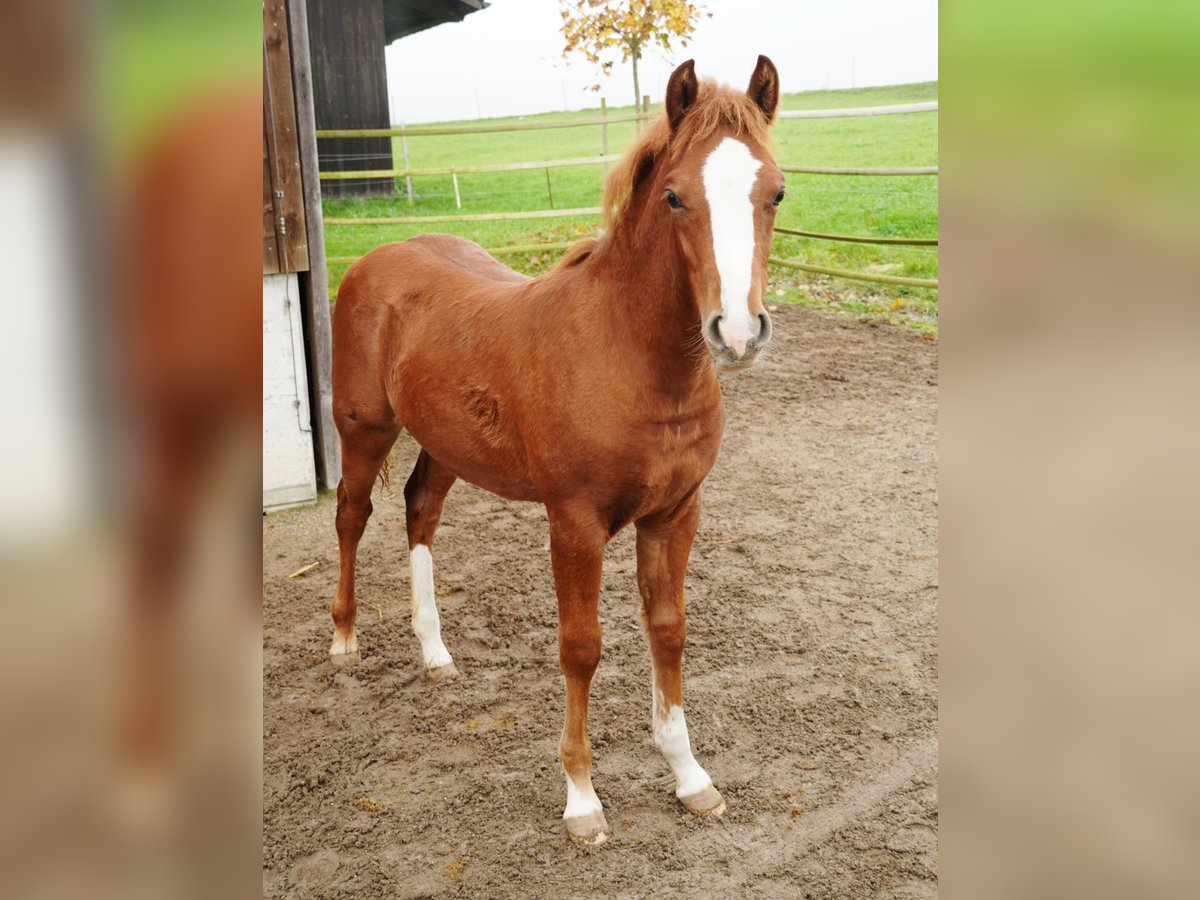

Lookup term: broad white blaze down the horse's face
[701,138,762,356]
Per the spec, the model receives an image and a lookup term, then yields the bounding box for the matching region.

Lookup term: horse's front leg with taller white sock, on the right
[636,491,725,816]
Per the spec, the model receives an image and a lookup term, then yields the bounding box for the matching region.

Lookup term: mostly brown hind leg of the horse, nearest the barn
[329,426,400,660]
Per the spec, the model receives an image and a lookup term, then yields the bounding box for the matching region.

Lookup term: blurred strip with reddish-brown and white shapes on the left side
[0,0,262,898]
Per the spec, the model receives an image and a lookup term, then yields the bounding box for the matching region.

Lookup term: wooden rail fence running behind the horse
[317,103,938,289]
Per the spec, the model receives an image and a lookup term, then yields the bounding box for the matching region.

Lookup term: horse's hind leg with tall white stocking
[404,450,458,682]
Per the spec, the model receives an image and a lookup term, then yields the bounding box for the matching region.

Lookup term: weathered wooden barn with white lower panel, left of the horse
[263,0,487,510]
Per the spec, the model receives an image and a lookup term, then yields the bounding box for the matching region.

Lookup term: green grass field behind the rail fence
[324,82,937,336]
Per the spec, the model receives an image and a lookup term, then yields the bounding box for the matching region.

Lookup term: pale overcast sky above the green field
[388,0,937,122]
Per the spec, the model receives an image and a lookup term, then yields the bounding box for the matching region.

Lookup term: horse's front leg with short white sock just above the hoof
[548,510,608,844]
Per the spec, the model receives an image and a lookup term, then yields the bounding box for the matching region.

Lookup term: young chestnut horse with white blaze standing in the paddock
[330,56,784,844]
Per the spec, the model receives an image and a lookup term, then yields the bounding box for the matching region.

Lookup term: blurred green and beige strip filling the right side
[940,1,1200,900]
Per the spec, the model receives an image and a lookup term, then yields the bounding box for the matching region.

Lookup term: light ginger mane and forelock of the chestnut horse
[604,78,770,228]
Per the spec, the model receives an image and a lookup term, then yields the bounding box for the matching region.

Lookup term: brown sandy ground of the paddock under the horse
[263,307,937,898]
